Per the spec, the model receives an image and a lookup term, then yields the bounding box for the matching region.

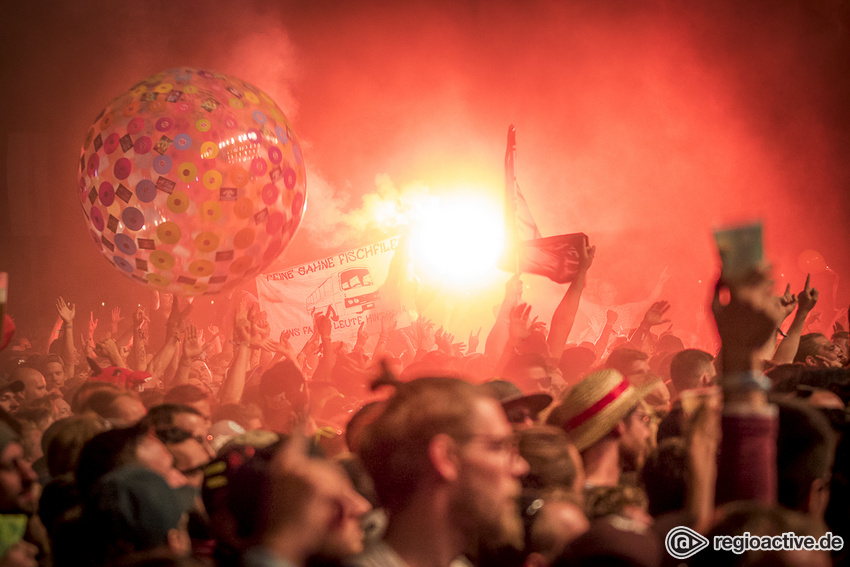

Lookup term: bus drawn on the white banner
[306,267,380,319]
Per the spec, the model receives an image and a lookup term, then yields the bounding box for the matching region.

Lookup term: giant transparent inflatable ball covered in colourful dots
[78,68,306,295]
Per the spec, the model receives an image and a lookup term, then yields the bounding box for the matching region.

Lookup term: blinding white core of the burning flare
[410,194,505,288]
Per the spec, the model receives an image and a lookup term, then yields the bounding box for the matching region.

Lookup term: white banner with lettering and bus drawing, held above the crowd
[257,236,415,350]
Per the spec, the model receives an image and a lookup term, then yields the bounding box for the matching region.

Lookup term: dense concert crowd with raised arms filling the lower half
[0,242,850,567]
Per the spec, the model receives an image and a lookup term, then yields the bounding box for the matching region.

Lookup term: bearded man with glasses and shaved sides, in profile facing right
[354,378,528,567]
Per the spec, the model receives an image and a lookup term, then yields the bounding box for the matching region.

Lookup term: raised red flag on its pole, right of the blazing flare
[501,124,587,283]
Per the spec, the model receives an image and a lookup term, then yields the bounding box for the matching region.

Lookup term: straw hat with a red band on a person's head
[549,369,657,451]
